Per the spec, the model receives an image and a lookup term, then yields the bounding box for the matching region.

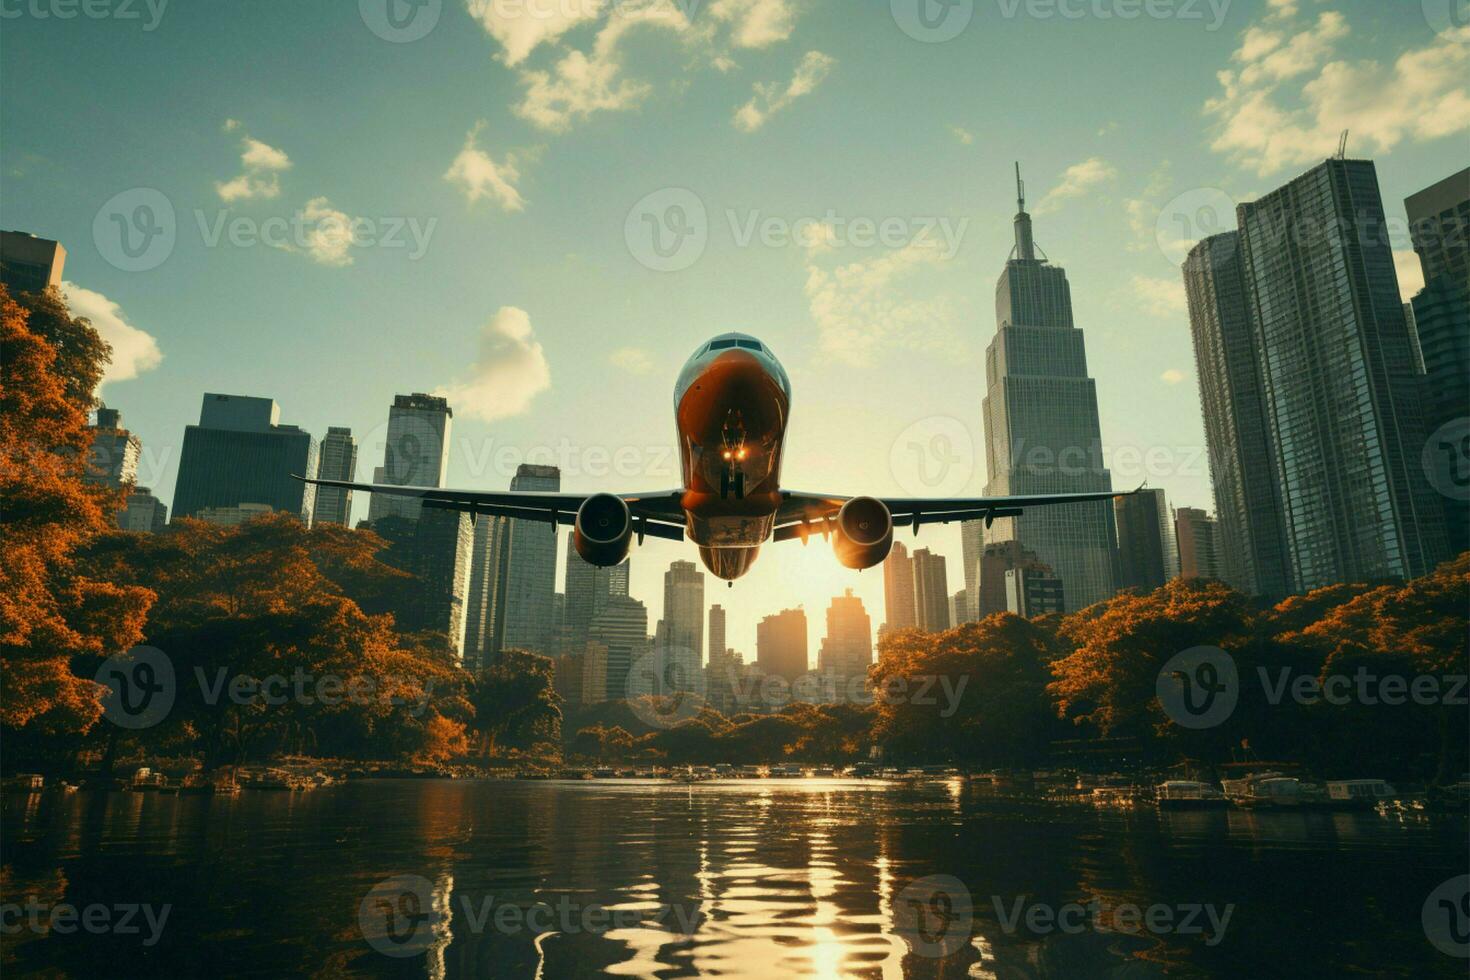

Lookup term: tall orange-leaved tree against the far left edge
[0,287,154,733]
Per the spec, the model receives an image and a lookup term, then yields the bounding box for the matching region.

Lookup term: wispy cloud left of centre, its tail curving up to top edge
[515,0,689,132]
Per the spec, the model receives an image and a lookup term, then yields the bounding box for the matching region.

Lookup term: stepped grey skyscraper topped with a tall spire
[966,170,1116,608]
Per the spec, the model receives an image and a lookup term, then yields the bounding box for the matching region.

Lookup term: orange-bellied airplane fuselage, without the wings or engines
[673,334,791,579]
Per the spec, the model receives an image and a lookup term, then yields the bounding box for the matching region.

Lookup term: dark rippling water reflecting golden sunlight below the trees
[0,780,1470,979]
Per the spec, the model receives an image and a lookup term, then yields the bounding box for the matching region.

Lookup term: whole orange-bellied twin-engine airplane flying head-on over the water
[298,334,1127,585]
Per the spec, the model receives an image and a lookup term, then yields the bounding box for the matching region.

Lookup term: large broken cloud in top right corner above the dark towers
[1205,11,1470,176]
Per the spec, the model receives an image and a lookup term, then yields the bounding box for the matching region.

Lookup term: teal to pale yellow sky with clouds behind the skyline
[0,0,1470,661]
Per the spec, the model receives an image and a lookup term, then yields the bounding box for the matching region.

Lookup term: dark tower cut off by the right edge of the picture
[1404,169,1470,554]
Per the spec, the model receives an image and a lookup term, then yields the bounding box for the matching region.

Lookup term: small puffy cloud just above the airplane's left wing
[434,306,551,422]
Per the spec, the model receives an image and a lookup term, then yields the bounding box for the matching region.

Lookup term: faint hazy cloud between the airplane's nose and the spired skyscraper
[806,241,950,366]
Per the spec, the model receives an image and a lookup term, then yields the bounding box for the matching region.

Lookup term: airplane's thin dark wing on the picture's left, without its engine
[295,476,685,541]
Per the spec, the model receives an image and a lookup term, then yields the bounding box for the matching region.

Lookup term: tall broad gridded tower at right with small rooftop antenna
[1240,159,1446,591]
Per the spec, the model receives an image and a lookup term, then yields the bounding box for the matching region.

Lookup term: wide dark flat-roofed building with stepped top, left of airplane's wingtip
[173,394,316,523]
